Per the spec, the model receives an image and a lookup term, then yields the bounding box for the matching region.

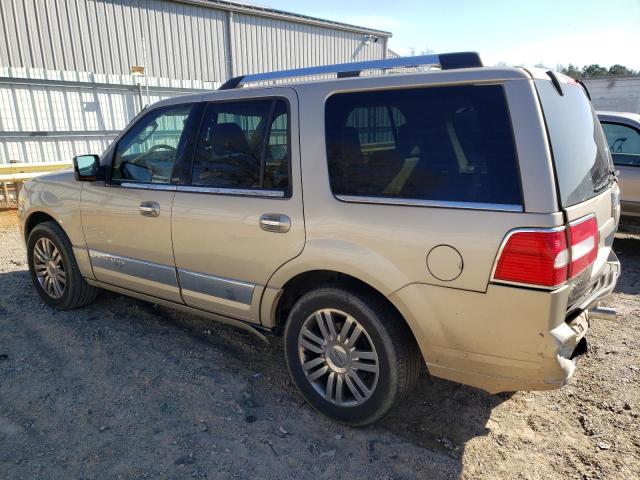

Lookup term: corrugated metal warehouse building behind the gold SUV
[0,0,391,163]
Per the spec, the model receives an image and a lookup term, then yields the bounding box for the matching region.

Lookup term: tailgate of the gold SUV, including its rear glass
[535,77,619,302]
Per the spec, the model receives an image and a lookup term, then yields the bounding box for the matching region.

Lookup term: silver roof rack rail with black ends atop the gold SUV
[218,52,482,90]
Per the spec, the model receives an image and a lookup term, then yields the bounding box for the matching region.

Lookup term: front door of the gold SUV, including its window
[81,104,199,302]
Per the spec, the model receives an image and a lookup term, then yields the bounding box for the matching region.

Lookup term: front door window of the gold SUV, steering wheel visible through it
[111,104,193,184]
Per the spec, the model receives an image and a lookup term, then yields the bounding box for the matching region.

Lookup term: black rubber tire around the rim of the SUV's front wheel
[27,222,99,310]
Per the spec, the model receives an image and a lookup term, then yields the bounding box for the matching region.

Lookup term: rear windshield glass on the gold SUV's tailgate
[536,80,611,207]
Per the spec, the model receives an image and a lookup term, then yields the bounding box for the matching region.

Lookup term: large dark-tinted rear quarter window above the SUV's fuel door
[325,85,522,205]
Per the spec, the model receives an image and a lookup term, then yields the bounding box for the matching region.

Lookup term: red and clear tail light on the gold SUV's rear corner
[493,215,599,288]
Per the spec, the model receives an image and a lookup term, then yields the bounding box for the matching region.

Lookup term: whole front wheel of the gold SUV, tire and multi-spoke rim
[27,222,98,310]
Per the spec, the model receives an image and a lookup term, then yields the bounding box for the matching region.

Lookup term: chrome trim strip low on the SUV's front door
[89,250,178,288]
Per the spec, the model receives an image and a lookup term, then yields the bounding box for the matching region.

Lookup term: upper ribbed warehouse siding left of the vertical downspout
[0,0,228,81]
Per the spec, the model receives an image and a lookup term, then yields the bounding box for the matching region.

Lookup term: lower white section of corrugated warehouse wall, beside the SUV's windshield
[0,69,210,163]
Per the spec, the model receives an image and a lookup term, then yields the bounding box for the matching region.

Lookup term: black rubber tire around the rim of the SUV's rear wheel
[284,285,422,426]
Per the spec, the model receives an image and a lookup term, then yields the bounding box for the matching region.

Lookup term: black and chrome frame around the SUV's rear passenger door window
[185,95,293,199]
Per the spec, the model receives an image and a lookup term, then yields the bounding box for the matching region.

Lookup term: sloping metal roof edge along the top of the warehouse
[173,0,392,38]
